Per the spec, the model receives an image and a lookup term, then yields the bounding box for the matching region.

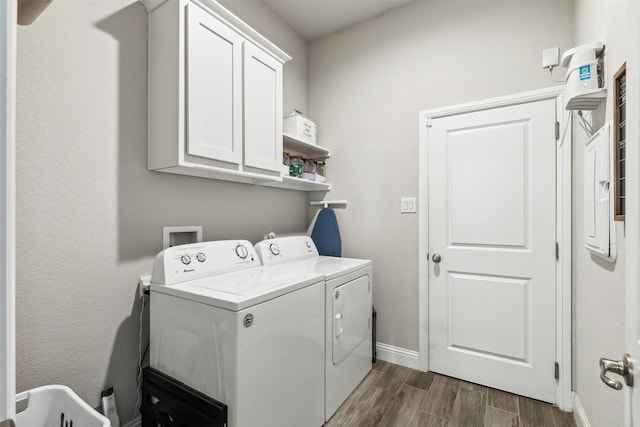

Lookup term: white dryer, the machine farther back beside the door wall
[255,236,373,421]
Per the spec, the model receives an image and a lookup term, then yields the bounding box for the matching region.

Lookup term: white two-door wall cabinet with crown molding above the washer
[148,0,291,183]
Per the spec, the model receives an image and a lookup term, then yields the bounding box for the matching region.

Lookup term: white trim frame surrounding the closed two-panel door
[418,86,573,411]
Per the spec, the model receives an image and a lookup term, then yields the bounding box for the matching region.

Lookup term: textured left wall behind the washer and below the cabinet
[16,0,307,422]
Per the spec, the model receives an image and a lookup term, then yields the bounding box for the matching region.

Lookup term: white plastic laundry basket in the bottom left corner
[16,385,111,427]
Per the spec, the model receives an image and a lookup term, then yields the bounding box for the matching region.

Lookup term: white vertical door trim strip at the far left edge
[0,0,18,420]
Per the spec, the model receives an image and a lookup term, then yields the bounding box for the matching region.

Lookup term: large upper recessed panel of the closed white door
[446,121,531,249]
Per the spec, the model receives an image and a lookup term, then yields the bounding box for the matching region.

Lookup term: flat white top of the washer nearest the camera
[151,267,324,311]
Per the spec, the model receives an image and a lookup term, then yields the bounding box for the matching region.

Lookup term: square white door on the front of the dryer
[332,275,371,365]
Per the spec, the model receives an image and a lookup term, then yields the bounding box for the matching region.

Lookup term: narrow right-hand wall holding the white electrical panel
[573,1,637,426]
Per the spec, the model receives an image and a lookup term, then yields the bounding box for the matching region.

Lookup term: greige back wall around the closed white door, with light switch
[308,1,573,350]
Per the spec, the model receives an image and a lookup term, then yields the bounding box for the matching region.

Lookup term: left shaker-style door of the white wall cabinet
[186,4,243,164]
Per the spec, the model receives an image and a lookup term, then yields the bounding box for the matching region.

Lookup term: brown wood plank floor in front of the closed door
[325,361,576,427]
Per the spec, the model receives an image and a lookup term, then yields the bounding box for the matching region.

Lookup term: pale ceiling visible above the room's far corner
[262,0,413,41]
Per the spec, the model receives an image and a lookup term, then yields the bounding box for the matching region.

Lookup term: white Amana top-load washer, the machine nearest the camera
[150,240,324,427]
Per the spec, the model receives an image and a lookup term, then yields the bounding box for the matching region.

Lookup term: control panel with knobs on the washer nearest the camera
[151,240,260,285]
